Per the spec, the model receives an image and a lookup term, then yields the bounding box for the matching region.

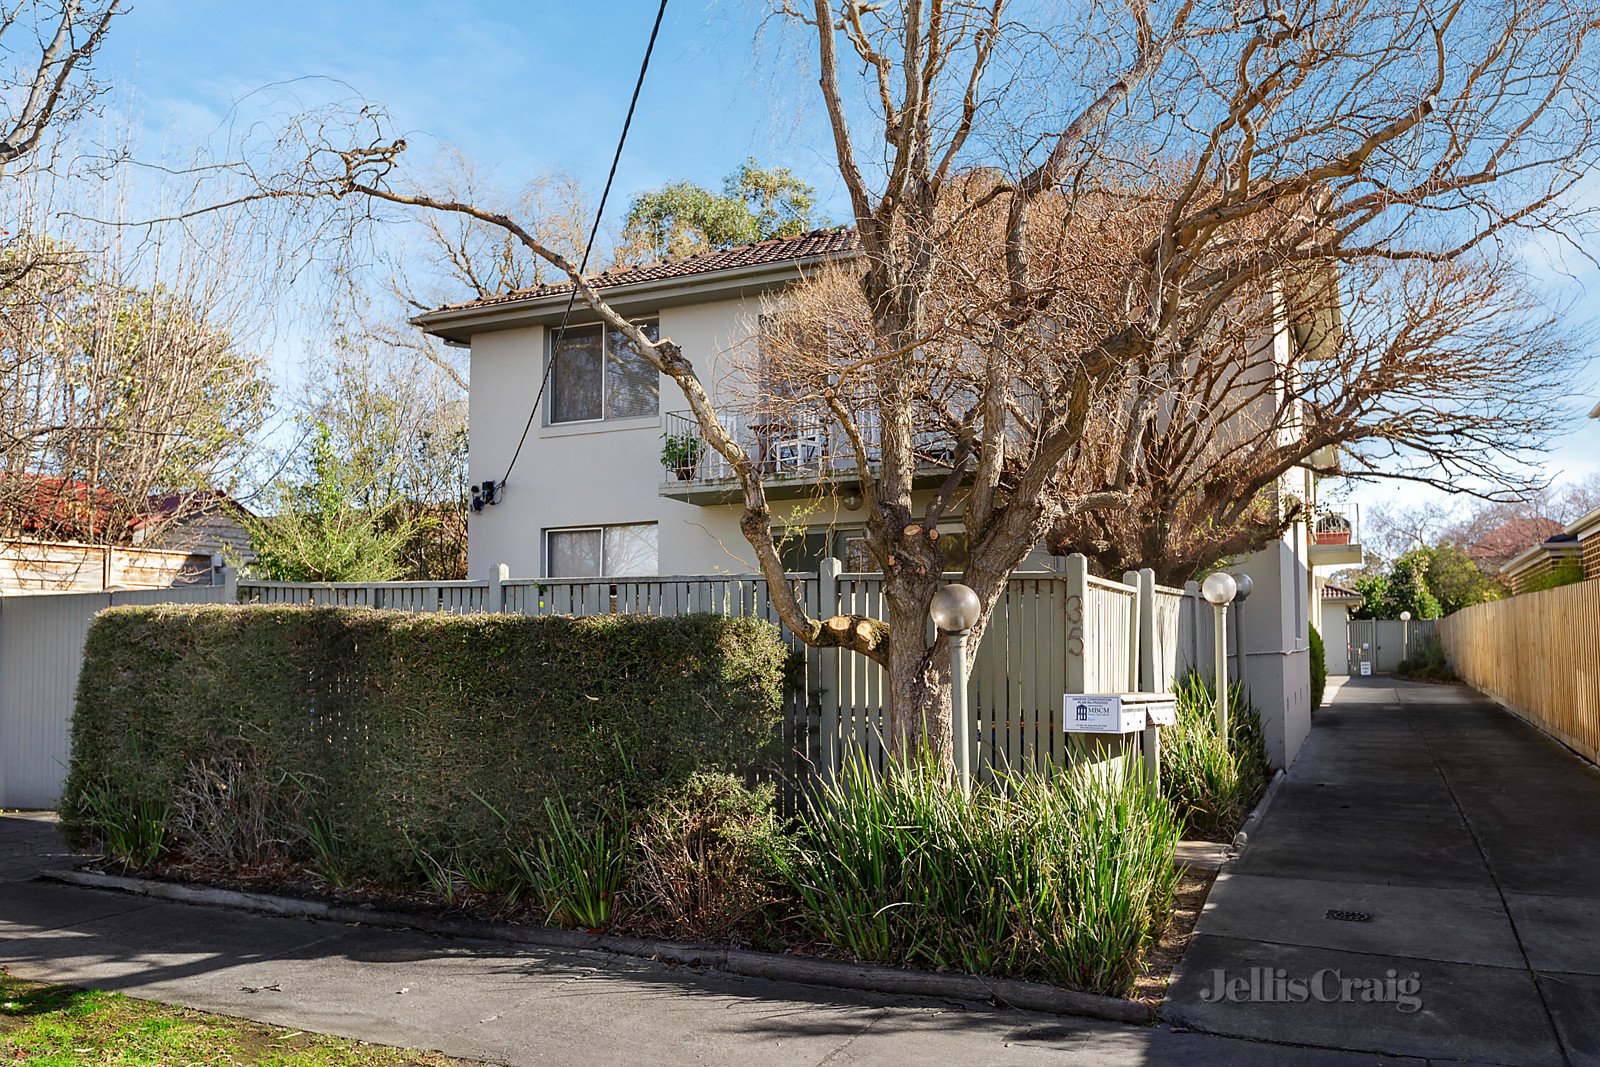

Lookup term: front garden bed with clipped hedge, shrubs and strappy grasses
[62,608,1264,1017]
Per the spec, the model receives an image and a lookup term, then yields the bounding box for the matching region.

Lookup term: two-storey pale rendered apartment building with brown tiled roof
[414,230,1360,765]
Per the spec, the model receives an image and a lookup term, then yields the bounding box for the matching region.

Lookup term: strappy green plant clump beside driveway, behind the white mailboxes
[1162,673,1272,838]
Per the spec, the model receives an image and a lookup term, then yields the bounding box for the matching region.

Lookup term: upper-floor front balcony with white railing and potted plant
[661,411,955,504]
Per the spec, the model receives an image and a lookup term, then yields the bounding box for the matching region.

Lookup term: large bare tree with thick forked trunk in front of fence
[178,0,1600,749]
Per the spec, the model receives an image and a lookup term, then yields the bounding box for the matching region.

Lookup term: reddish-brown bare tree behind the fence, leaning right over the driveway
[1048,256,1574,584]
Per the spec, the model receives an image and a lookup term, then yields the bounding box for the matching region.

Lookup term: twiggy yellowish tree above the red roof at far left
[0,163,270,544]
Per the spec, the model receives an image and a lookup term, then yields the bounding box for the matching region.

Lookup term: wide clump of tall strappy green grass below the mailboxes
[776,758,1181,997]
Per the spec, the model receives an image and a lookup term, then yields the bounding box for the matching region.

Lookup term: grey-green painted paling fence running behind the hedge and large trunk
[0,557,1213,808]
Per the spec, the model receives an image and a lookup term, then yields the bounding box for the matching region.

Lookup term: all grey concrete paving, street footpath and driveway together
[0,686,1600,1067]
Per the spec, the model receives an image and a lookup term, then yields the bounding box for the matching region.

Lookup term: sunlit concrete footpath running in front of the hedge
[0,816,1401,1067]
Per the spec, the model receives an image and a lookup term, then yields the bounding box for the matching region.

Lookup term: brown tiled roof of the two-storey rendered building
[411,229,861,341]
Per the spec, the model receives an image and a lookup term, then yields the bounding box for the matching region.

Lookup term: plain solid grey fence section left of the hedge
[0,585,226,808]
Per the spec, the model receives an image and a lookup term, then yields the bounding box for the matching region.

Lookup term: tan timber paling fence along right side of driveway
[1438,579,1600,761]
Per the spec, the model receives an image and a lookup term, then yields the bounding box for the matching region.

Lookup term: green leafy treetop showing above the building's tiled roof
[618,158,816,262]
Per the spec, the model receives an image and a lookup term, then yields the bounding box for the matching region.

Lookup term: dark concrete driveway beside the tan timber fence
[1165,678,1600,1067]
